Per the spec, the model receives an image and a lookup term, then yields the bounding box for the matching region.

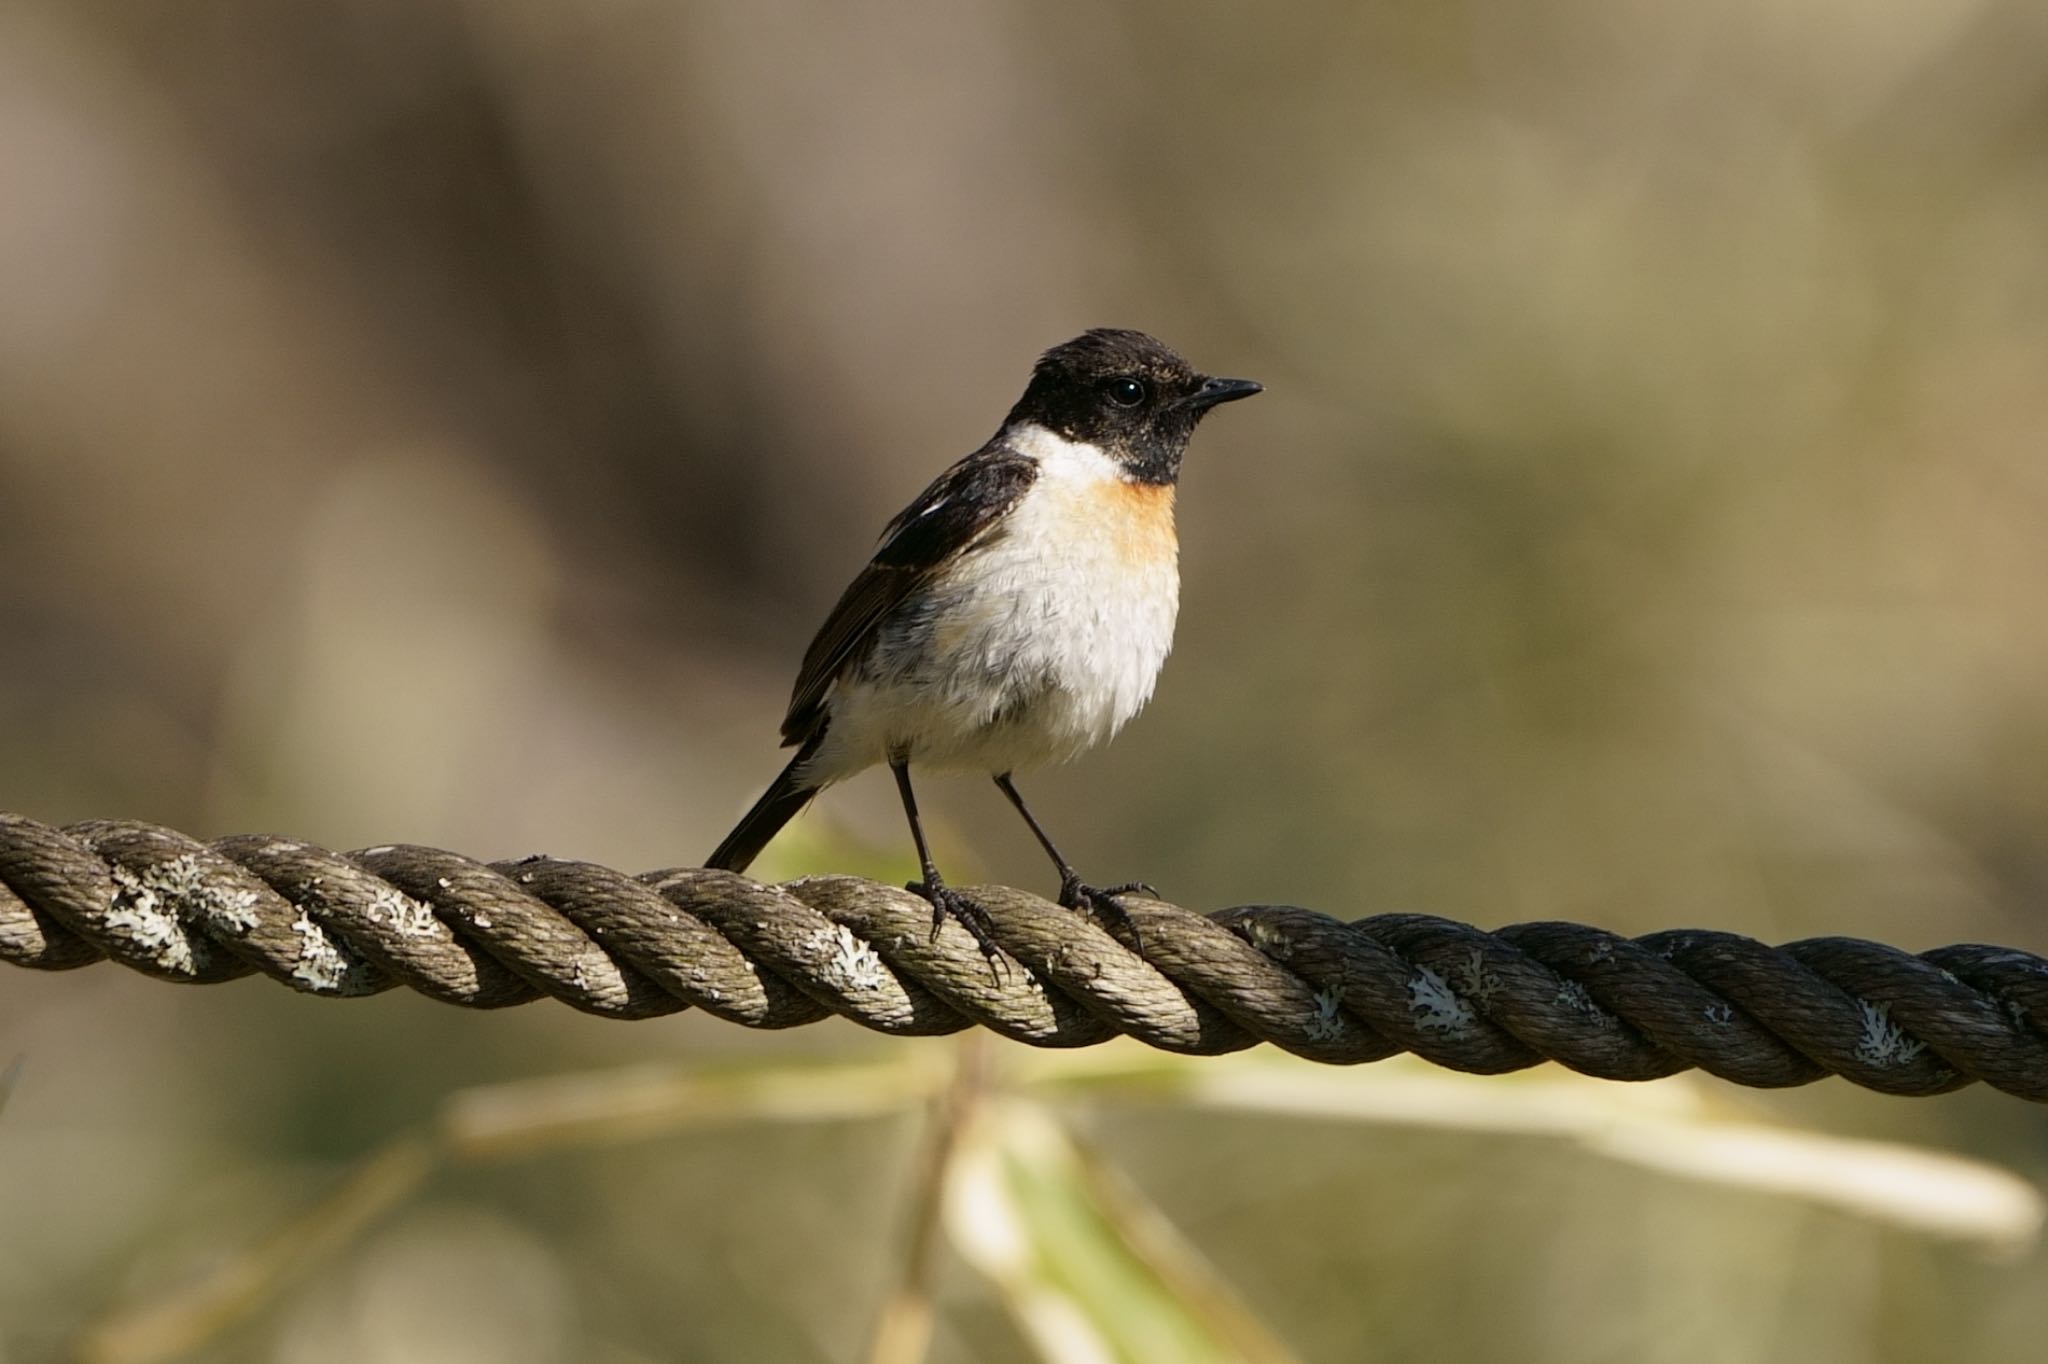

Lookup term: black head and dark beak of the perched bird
[1008,328,1260,483]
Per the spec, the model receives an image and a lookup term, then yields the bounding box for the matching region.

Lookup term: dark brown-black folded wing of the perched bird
[782,442,1038,748]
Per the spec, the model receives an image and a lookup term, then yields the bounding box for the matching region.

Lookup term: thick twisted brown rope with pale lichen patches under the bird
[0,815,2048,1100]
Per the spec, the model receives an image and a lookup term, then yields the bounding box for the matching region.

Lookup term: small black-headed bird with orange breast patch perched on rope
[705,328,1264,950]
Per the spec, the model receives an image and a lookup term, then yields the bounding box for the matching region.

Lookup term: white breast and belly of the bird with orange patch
[807,426,1180,784]
